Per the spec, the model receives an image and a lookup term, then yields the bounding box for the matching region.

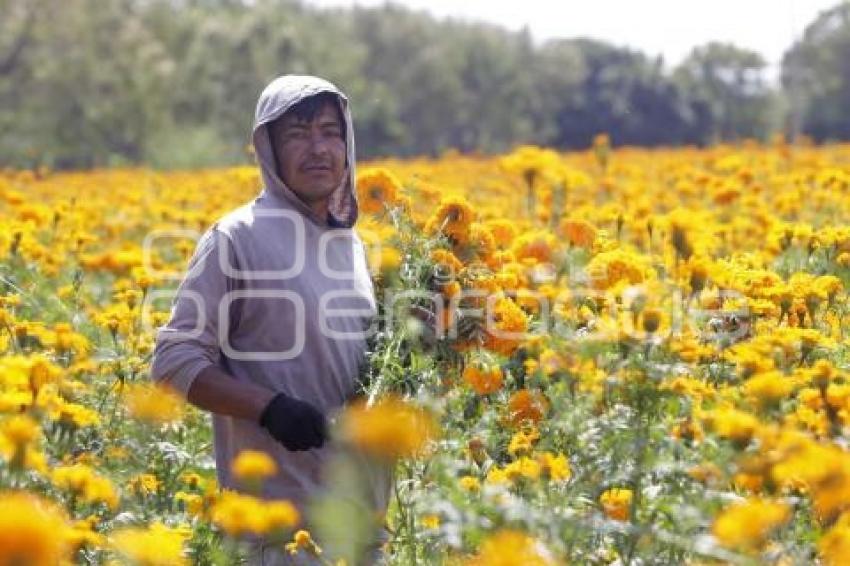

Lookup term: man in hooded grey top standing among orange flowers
[151,75,390,564]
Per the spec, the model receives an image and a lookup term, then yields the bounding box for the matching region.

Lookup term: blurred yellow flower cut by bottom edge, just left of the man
[111,522,191,566]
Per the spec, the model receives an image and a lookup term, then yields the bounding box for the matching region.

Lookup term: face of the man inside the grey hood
[270,103,345,204]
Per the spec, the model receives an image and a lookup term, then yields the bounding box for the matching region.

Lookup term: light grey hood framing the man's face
[252,75,357,228]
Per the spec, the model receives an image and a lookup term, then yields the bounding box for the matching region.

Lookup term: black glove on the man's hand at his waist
[260,393,328,451]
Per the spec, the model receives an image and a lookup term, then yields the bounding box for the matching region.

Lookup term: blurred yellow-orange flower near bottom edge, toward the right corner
[712,497,791,549]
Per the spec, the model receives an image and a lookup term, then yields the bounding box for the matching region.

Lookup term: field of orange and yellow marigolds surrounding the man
[0,136,850,565]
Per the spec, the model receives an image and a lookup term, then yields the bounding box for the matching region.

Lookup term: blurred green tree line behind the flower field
[0,0,850,168]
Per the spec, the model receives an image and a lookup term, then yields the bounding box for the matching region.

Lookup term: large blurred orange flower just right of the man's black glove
[342,398,437,460]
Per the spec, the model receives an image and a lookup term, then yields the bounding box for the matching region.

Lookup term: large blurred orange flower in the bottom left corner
[0,491,72,566]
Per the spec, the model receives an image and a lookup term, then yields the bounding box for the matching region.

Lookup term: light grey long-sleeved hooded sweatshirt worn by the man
[151,75,390,528]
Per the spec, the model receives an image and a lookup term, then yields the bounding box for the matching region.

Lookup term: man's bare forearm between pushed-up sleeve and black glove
[188,365,276,423]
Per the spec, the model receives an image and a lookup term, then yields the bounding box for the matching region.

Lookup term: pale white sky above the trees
[306,0,842,78]
